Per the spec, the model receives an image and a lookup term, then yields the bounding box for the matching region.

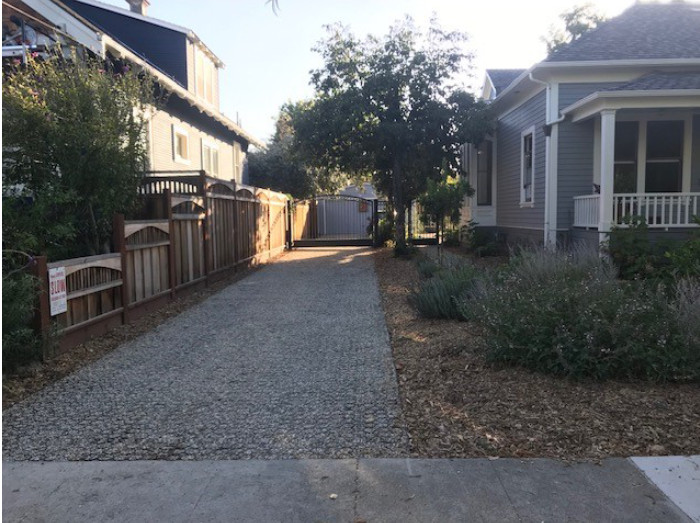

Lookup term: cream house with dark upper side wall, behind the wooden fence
[3,0,264,183]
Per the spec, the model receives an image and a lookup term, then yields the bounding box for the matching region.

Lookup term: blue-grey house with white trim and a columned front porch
[464,3,700,249]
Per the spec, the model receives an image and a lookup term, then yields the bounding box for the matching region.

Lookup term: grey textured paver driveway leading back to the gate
[3,248,406,460]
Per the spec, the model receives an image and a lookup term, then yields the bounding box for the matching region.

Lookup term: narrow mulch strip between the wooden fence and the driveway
[2,260,280,410]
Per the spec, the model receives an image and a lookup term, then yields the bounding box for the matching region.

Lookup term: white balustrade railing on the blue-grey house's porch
[574,192,700,229]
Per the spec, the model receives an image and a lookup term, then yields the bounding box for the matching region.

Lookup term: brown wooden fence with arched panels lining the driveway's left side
[35,173,288,350]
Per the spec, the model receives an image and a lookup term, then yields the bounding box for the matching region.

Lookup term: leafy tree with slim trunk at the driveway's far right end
[293,18,490,251]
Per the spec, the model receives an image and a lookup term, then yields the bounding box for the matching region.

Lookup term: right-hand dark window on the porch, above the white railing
[645,120,684,192]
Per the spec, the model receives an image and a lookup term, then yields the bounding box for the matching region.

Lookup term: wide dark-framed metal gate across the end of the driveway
[290,196,385,247]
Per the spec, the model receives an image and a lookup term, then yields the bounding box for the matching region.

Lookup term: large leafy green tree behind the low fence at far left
[2,54,156,258]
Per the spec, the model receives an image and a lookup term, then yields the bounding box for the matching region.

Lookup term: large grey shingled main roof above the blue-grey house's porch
[545,3,700,62]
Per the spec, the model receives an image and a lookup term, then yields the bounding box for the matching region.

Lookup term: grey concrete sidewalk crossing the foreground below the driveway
[3,457,700,523]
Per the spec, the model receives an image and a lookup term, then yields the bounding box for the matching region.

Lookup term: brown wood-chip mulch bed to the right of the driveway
[374,249,700,461]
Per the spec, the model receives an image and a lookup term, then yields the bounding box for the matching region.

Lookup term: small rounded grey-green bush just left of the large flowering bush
[410,265,478,319]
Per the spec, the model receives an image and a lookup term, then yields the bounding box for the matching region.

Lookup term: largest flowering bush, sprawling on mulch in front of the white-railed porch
[478,250,700,381]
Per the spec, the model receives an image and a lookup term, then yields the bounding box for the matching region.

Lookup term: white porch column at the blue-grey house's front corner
[598,109,615,243]
